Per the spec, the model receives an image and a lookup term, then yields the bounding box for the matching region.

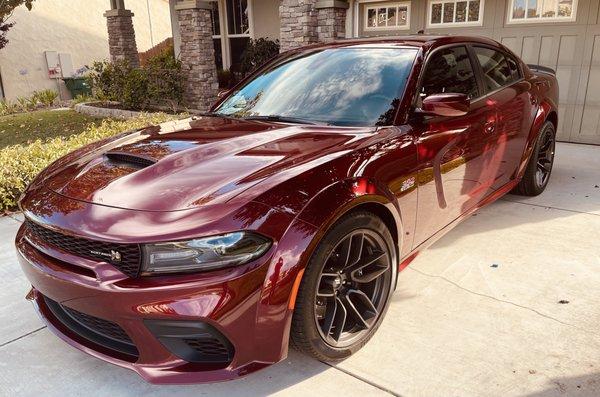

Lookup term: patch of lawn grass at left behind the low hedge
[0,110,102,149]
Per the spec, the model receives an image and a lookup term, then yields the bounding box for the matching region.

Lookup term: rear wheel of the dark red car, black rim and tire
[512,121,556,196]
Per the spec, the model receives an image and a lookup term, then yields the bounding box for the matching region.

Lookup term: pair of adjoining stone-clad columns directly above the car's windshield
[279,0,348,52]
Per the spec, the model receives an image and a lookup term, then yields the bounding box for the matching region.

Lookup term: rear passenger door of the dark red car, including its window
[472,45,537,193]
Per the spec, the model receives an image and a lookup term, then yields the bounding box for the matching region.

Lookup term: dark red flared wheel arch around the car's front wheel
[256,178,405,362]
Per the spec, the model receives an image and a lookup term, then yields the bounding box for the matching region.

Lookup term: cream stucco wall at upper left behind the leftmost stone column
[0,0,171,99]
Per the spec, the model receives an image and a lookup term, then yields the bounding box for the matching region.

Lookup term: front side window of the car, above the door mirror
[420,46,479,99]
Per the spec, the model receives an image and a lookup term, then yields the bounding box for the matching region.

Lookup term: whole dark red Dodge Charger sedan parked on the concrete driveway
[16,35,558,383]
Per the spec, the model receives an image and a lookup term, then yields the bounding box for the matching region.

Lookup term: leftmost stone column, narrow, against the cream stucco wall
[104,8,140,67]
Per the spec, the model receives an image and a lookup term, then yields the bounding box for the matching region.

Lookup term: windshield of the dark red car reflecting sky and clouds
[215,48,417,126]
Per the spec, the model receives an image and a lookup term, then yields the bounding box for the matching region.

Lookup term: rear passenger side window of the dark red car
[474,47,519,91]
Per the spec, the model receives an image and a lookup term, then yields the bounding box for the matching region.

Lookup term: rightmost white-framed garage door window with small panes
[509,0,577,23]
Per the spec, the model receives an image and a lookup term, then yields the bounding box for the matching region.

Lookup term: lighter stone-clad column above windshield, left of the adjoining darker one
[279,0,318,52]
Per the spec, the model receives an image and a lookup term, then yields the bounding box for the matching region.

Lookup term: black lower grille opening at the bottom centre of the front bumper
[43,296,139,359]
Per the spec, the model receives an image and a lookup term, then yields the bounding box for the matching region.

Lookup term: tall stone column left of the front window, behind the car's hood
[175,0,219,112]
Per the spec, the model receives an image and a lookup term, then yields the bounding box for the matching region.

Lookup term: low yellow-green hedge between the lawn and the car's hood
[0,113,179,212]
